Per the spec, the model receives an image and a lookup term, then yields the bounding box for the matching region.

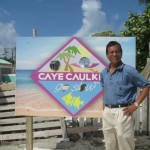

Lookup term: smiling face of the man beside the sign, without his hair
[107,45,122,65]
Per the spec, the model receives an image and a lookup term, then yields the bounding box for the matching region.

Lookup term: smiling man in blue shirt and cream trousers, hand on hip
[101,41,150,150]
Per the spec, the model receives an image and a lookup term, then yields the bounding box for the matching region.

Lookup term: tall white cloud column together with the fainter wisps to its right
[75,0,124,36]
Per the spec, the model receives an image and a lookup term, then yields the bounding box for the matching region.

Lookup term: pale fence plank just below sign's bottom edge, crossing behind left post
[0,117,59,125]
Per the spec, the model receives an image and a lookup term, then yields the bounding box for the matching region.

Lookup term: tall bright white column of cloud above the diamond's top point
[75,0,111,36]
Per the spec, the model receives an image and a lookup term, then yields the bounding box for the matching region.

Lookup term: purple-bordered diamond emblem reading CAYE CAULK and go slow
[31,37,107,116]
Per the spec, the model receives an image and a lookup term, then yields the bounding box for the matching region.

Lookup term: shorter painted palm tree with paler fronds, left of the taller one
[56,52,75,72]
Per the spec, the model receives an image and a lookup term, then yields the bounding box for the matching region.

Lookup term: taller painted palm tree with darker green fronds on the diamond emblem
[65,46,80,72]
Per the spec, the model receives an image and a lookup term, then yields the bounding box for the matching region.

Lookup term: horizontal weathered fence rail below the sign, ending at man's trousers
[67,126,102,134]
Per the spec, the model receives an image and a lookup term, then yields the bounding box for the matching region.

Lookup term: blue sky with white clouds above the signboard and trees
[0,0,145,48]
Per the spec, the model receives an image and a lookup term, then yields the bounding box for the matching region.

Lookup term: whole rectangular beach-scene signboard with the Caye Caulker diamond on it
[16,37,135,117]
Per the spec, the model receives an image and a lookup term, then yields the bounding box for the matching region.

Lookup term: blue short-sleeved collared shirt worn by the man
[100,63,149,105]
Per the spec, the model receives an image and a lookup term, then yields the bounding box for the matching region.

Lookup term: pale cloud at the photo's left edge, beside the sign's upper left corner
[0,22,17,48]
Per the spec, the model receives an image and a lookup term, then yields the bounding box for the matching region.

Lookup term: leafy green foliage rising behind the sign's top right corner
[92,5,150,71]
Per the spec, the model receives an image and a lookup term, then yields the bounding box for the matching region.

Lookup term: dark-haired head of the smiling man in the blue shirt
[106,41,122,65]
